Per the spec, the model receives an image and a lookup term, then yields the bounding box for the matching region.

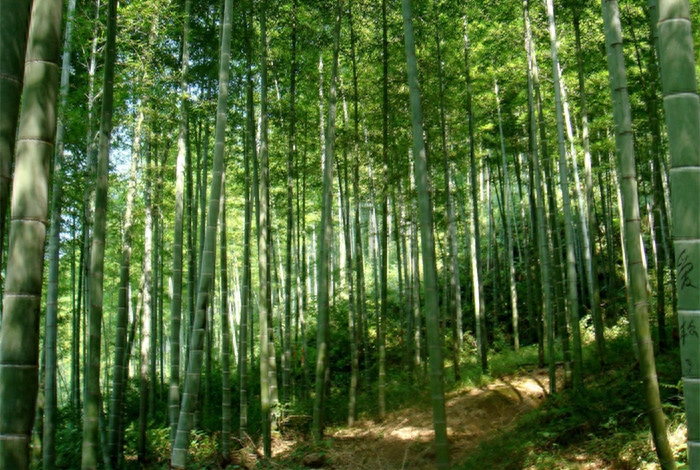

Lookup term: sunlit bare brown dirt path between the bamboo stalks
[282,371,549,470]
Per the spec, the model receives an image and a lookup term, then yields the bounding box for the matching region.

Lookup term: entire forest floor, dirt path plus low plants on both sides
[113,328,686,470]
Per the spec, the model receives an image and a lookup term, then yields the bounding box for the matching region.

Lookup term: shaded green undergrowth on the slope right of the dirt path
[457,328,685,470]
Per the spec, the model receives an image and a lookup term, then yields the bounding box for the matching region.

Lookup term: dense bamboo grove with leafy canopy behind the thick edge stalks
[0,0,700,468]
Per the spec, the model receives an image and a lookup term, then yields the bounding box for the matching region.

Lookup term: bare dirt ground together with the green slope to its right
[249,336,686,470]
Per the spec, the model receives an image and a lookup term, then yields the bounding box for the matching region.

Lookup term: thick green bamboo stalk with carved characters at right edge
[658,0,700,464]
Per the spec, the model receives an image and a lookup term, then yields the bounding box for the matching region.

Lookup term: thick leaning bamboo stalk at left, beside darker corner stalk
[0,0,63,470]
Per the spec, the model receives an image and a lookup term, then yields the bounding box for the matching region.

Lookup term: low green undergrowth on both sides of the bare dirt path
[50,320,685,470]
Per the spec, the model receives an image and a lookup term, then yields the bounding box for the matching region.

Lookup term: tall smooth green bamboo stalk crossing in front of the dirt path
[401,0,450,469]
